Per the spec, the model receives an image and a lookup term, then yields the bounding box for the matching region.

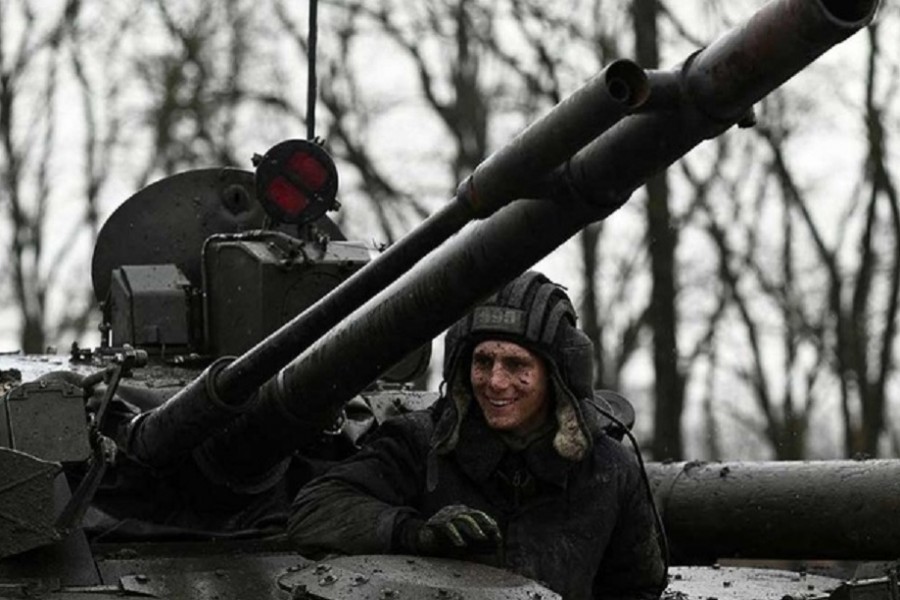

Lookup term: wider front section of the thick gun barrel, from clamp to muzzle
[545,0,878,207]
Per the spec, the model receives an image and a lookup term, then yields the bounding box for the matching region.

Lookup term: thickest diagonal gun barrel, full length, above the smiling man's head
[192,0,877,488]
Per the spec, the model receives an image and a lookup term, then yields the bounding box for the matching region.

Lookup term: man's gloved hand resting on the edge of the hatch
[417,504,503,555]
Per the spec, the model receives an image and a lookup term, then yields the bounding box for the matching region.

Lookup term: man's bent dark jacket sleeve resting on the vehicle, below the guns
[288,412,431,554]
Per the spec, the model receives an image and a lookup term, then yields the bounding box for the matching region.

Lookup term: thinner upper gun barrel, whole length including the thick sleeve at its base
[125,60,649,466]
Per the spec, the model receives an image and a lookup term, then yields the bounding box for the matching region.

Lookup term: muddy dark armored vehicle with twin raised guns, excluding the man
[0,0,900,600]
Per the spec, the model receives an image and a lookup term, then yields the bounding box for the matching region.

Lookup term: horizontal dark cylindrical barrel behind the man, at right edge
[647,460,900,562]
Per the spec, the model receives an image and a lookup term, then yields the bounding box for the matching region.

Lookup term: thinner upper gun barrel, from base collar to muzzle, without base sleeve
[216,59,650,403]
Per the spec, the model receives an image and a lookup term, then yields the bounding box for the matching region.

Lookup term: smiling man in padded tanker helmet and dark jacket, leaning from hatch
[289,272,665,600]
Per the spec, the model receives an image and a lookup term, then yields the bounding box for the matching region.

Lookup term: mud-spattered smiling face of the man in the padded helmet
[470,340,550,435]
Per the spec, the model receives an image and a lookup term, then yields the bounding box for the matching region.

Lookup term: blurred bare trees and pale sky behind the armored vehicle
[0,0,900,459]
